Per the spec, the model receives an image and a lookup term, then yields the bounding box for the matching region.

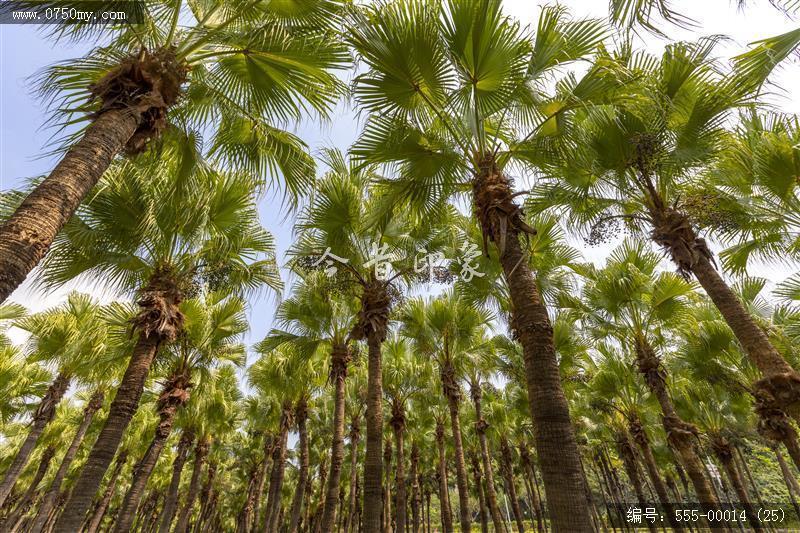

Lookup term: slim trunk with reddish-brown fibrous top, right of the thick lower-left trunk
[114,369,192,533]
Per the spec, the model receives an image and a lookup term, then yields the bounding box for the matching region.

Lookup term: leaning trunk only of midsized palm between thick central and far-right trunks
[634,335,719,511]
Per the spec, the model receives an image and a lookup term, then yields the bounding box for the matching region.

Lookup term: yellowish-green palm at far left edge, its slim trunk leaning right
[0,293,106,505]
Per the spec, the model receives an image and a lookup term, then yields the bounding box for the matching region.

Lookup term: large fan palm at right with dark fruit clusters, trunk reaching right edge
[528,39,800,424]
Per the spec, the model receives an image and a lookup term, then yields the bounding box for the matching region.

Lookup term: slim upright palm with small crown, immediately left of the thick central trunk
[399,293,491,533]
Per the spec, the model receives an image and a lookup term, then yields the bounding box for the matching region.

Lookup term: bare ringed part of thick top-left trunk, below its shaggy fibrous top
[0,109,140,303]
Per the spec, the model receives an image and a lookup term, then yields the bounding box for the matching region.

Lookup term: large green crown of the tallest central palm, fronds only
[350,0,611,212]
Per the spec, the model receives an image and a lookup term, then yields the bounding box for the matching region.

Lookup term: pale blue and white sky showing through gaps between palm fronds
[0,0,800,364]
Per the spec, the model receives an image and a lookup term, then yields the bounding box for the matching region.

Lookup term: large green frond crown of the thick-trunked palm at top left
[39,0,348,195]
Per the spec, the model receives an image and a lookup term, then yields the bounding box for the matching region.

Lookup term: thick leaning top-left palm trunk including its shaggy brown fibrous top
[0,48,187,303]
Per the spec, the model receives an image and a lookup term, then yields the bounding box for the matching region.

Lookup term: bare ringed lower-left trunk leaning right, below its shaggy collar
[54,334,161,533]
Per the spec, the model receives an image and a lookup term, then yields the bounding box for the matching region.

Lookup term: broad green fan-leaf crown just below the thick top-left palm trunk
[41,139,281,295]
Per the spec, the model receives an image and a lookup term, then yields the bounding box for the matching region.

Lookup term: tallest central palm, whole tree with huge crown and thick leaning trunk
[350,0,617,531]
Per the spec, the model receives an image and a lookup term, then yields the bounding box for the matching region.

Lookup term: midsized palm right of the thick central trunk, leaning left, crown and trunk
[577,241,719,508]
